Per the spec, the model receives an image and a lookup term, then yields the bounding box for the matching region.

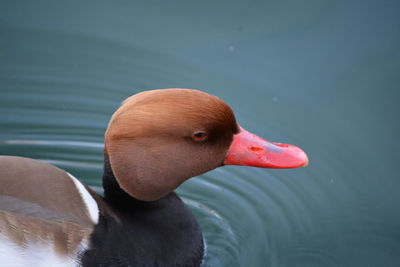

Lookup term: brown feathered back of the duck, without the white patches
[0,156,94,256]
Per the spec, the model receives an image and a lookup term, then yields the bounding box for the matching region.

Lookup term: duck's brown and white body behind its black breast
[0,156,95,266]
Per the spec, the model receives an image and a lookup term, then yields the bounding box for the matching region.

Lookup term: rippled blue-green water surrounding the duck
[0,0,400,267]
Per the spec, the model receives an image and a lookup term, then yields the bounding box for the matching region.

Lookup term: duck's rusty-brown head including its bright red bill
[105,89,308,201]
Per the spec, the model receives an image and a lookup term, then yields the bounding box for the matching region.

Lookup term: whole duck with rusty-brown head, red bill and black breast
[0,88,308,267]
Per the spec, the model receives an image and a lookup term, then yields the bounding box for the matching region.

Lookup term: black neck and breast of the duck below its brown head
[81,156,203,267]
